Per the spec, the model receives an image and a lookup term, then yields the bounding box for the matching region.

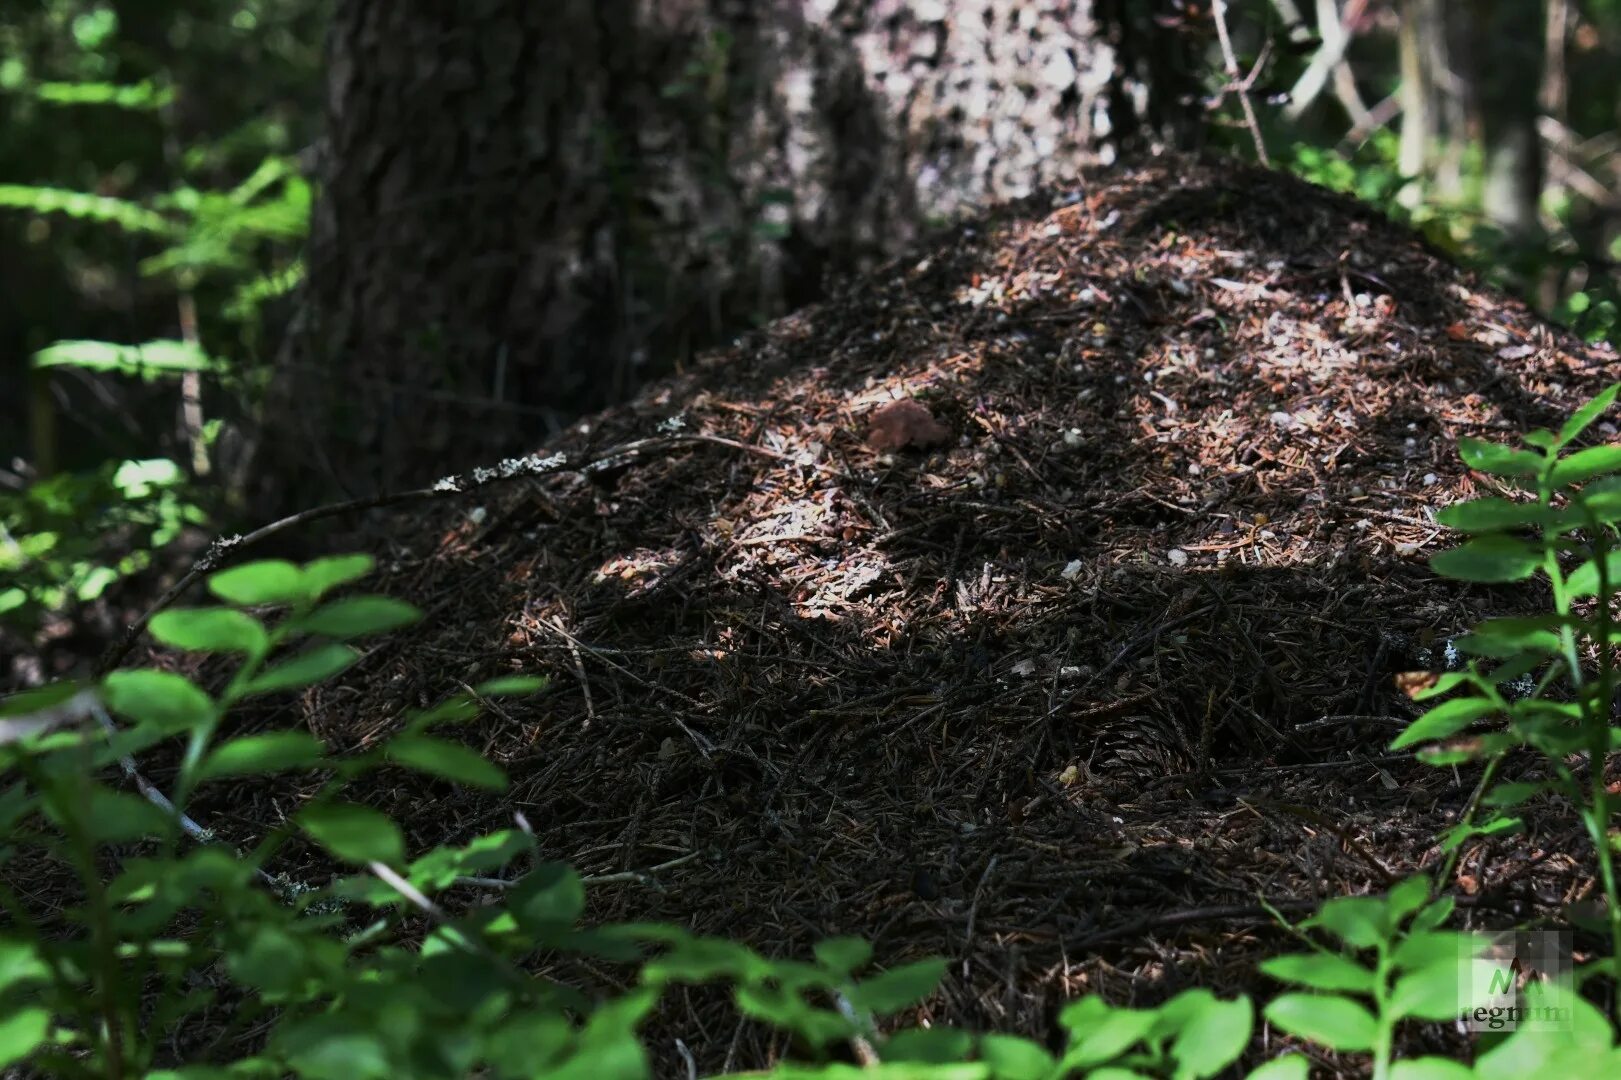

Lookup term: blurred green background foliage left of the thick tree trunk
[0,0,327,628]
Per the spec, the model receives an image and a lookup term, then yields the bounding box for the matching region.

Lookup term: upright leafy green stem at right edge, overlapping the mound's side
[1392,377,1621,973]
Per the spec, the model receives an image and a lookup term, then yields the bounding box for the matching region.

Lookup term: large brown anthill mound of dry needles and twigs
[199,161,1616,1069]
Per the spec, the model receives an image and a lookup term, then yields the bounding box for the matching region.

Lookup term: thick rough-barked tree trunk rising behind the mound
[269,0,1196,498]
